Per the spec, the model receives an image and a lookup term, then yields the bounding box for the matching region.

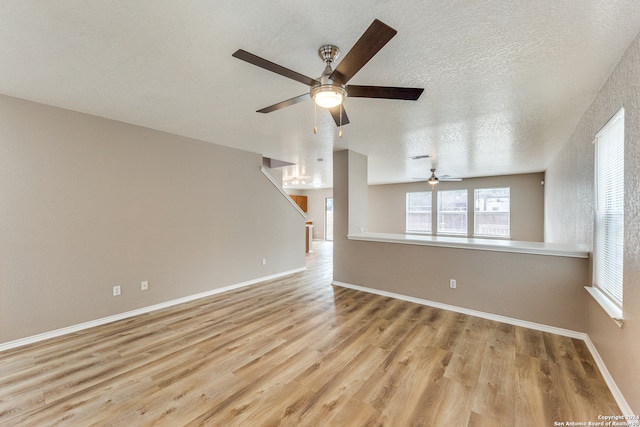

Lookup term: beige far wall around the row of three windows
[368,173,544,242]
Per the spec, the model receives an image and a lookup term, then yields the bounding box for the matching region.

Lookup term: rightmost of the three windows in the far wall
[473,187,511,237]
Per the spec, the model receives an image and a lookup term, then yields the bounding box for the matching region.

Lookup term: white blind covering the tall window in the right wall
[593,109,624,308]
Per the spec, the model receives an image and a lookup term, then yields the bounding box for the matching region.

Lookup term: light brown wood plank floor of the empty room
[0,243,620,427]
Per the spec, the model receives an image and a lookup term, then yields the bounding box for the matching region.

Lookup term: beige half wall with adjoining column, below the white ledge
[333,152,588,331]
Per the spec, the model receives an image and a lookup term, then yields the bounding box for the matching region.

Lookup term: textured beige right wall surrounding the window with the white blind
[545,30,640,413]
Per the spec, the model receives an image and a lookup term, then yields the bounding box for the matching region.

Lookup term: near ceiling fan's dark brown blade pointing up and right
[329,19,397,84]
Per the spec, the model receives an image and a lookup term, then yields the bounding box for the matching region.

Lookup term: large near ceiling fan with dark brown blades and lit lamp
[233,19,424,130]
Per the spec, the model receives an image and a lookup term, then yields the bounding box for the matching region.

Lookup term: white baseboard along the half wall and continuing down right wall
[332,280,634,415]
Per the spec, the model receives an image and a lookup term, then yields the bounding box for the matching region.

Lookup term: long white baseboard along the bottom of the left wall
[0,267,306,351]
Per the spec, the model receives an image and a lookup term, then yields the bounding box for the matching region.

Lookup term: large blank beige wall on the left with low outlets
[0,96,305,342]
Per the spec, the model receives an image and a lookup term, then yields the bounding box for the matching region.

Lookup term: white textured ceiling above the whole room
[0,0,640,186]
